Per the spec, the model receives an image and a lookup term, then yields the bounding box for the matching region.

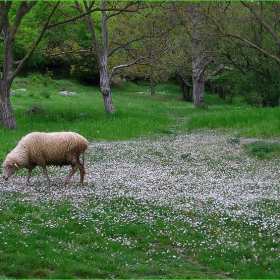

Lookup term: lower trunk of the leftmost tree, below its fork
[0,78,17,130]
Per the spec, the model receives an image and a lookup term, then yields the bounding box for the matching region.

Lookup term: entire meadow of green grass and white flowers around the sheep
[0,76,280,278]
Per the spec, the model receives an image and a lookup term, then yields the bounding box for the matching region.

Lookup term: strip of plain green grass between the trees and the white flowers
[3,76,280,147]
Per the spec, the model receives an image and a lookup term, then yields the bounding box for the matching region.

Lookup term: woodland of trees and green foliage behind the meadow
[0,1,280,129]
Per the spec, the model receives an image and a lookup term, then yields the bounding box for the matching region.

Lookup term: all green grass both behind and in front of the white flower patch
[0,78,280,278]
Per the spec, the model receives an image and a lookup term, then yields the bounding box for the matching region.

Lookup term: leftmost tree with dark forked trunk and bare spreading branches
[0,1,95,129]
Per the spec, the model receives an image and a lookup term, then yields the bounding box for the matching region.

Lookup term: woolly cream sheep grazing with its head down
[2,132,88,185]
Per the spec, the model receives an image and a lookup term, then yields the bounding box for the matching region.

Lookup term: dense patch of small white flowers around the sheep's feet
[0,131,280,266]
